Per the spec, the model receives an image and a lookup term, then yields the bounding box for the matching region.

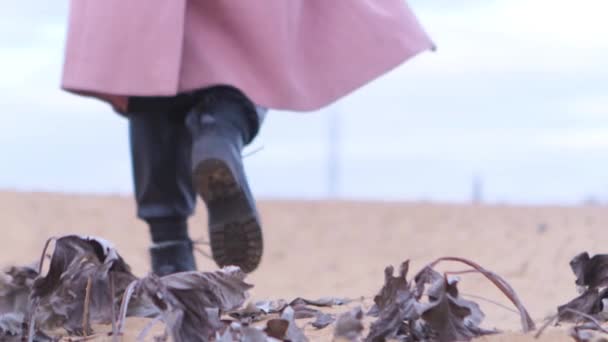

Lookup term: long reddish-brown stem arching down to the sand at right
[428,257,535,332]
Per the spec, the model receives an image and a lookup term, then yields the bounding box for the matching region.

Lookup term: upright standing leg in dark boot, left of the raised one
[129,112,196,275]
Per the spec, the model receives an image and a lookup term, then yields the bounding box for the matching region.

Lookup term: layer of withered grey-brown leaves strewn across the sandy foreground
[0,235,540,342]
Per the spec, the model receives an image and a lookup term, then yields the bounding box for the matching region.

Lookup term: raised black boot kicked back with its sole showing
[186,87,263,272]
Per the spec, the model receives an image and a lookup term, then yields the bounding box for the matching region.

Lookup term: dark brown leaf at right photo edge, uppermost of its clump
[570,252,608,288]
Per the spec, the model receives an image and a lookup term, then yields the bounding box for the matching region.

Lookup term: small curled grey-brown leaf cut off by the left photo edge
[0,266,38,314]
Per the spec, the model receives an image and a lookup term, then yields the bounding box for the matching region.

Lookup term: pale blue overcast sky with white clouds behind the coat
[0,0,608,203]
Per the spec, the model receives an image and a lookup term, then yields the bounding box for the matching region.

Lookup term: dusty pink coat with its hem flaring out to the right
[62,0,433,111]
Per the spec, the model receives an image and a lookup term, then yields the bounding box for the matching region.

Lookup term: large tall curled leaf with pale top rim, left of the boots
[31,235,135,332]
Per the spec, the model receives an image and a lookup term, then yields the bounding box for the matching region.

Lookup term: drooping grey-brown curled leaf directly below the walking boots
[136,267,252,342]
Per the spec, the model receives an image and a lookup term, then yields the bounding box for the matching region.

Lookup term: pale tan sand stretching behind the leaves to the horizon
[0,191,608,341]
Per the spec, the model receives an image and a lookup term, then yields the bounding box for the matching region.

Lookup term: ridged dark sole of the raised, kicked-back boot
[194,159,263,273]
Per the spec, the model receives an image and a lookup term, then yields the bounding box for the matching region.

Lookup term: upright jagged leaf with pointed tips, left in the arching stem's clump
[366,261,419,341]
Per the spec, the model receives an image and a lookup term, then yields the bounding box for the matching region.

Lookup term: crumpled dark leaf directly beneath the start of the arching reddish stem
[415,267,492,342]
